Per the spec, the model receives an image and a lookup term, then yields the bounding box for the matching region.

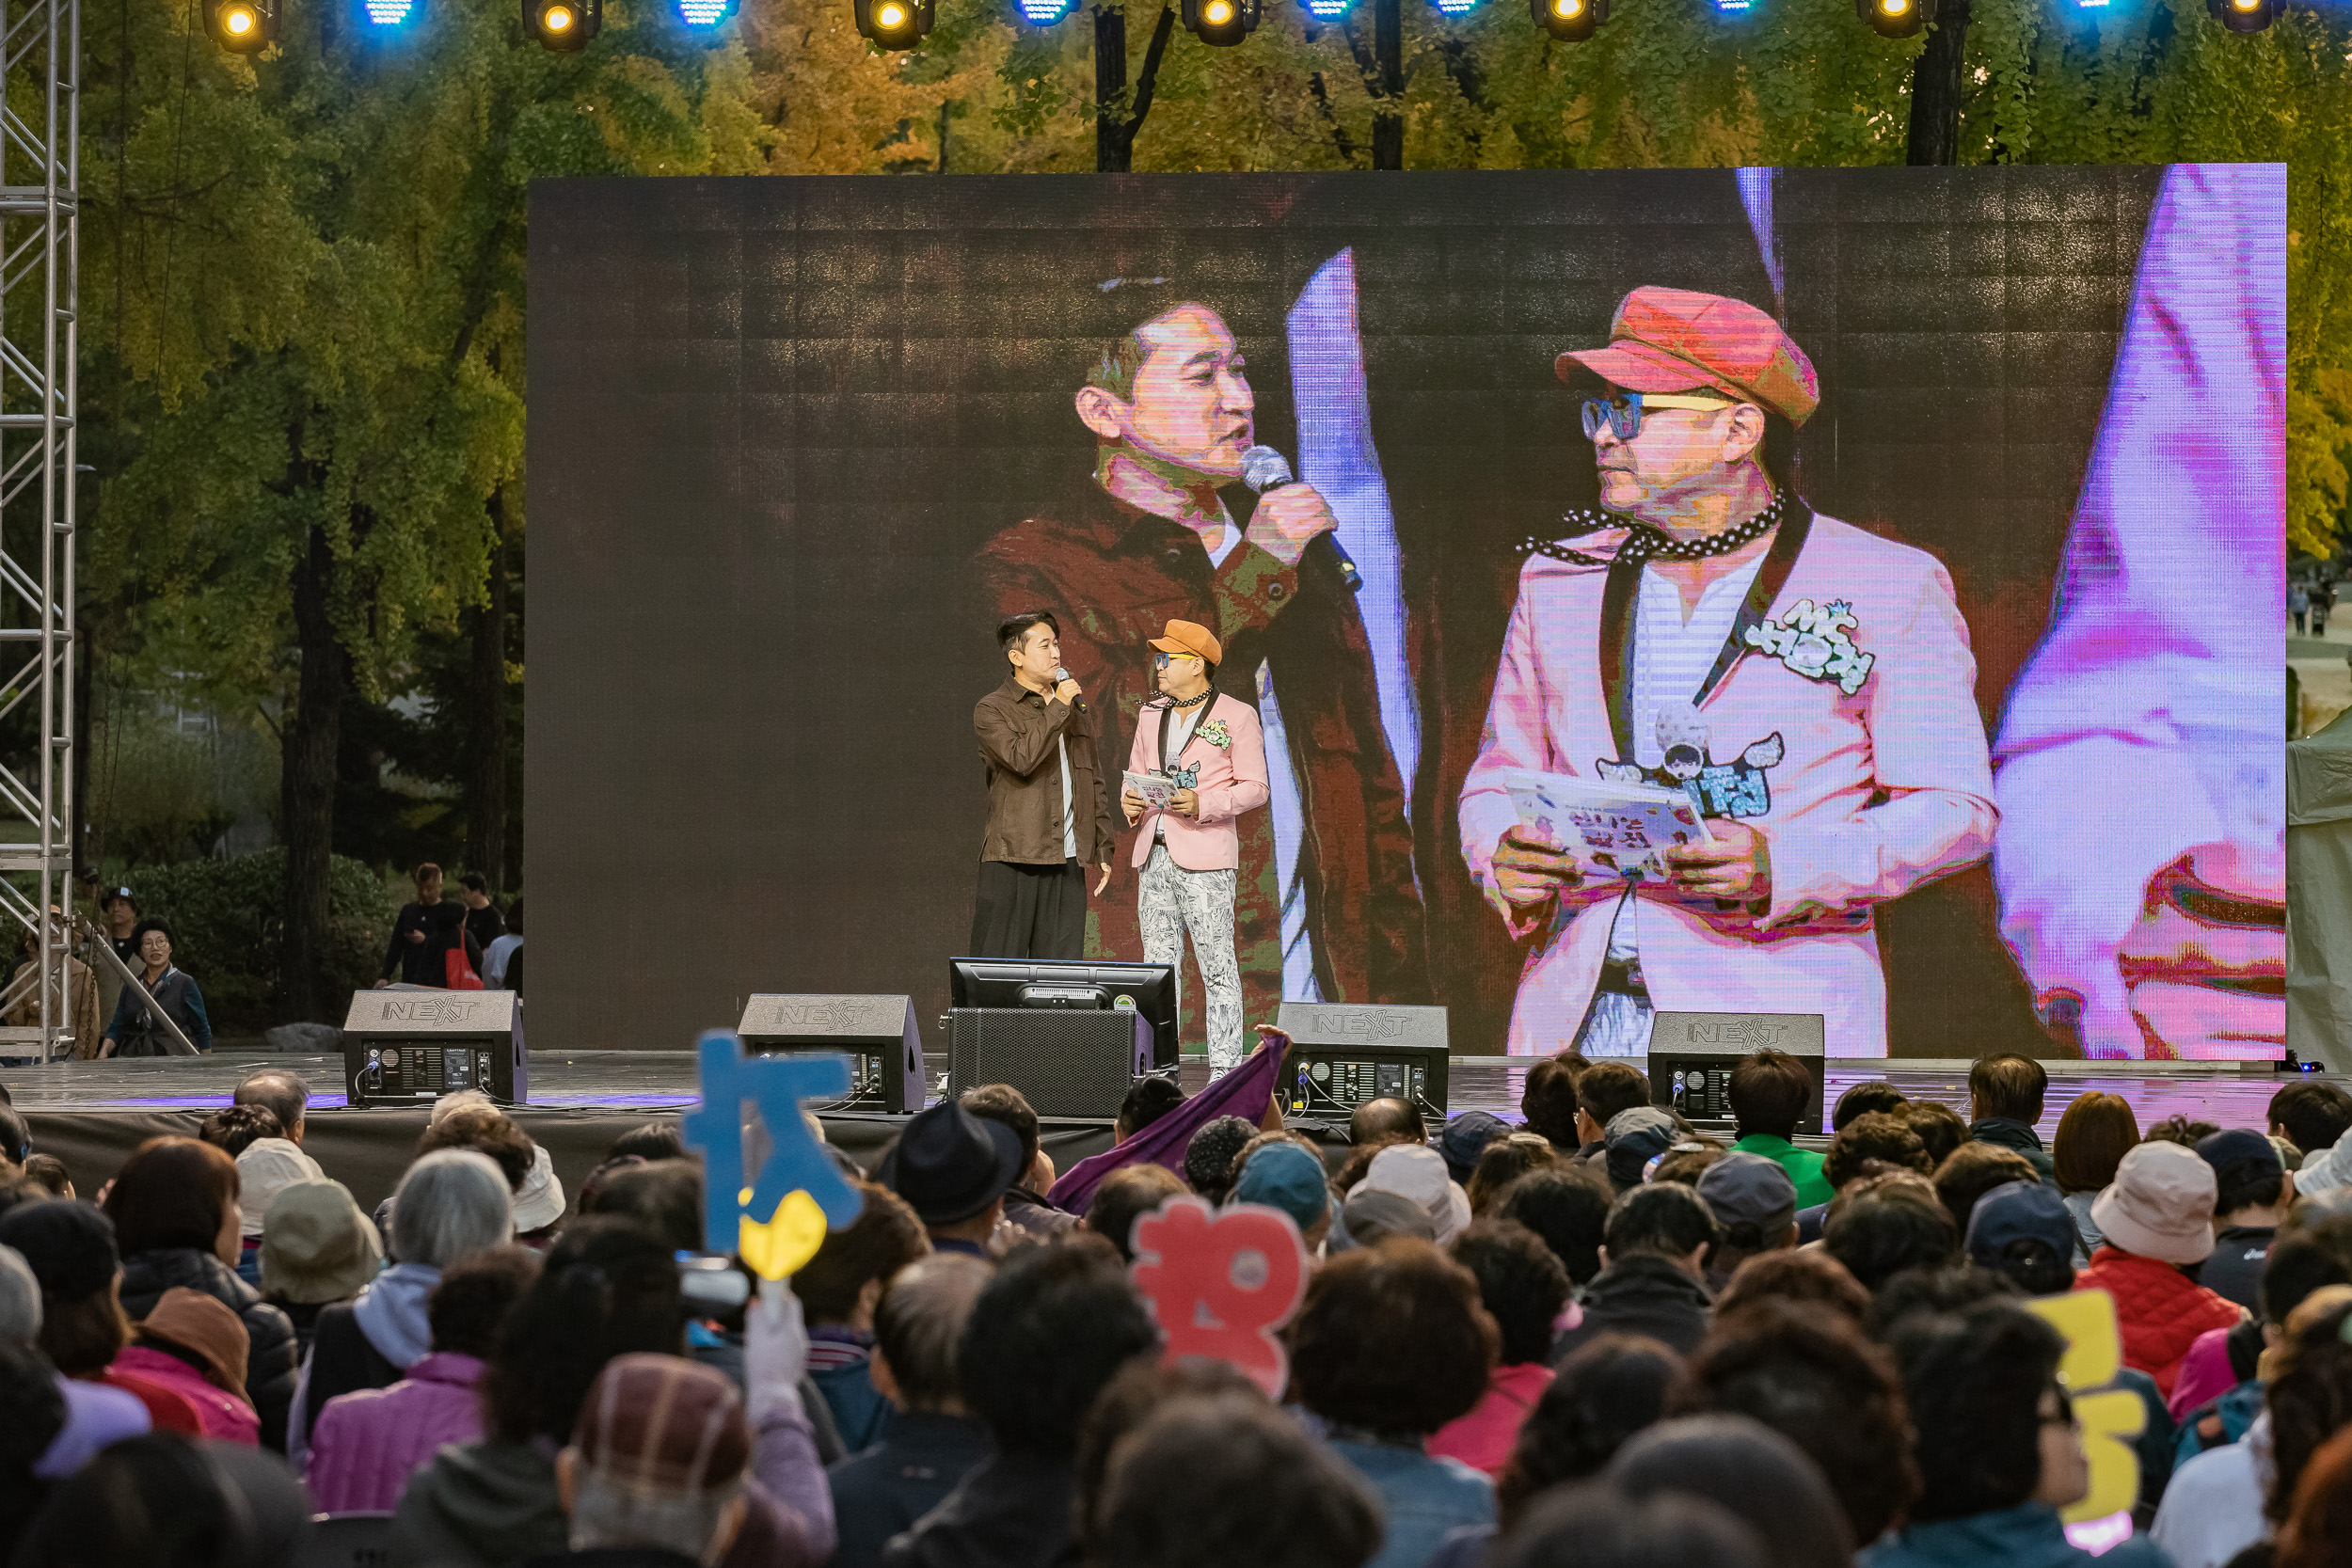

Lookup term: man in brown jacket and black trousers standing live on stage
[972,609,1118,959]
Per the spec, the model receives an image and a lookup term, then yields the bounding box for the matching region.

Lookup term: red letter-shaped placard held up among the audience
[1127,1196,1308,1399]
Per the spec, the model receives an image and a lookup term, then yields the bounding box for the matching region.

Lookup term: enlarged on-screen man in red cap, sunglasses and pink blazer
[1461,287,1997,1055]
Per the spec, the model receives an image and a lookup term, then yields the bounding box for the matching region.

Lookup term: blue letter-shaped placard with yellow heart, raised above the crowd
[682,1030,866,1279]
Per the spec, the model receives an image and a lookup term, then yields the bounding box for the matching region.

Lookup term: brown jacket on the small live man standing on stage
[972,674,1120,865]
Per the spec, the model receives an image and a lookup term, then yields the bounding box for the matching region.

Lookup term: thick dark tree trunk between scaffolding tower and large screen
[280,527,351,1022]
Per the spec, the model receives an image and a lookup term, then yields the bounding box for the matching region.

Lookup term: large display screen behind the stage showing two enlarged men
[525,165,2286,1058]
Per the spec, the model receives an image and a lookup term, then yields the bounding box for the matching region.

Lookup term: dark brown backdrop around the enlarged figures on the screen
[527,166,2162,1055]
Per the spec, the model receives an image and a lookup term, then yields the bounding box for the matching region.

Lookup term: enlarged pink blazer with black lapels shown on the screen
[1461,513,1999,1055]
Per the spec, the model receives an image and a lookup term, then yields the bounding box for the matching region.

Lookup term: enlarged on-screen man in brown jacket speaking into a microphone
[974,285,1430,1018]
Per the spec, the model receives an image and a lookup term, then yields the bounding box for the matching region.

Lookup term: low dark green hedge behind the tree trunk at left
[132,848,400,1030]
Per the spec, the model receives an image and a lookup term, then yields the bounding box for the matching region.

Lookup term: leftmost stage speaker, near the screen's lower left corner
[343,985,532,1105]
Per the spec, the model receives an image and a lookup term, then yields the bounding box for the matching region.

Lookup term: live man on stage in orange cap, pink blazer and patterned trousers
[1120,621,1268,1077]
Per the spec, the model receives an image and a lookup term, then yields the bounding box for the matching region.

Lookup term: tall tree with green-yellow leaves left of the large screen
[85,0,767,1018]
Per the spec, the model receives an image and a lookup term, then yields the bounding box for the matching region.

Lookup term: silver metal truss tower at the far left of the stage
[0,0,76,1060]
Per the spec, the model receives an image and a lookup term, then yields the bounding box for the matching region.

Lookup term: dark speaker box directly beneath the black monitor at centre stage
[948,1006,1152,1119]
